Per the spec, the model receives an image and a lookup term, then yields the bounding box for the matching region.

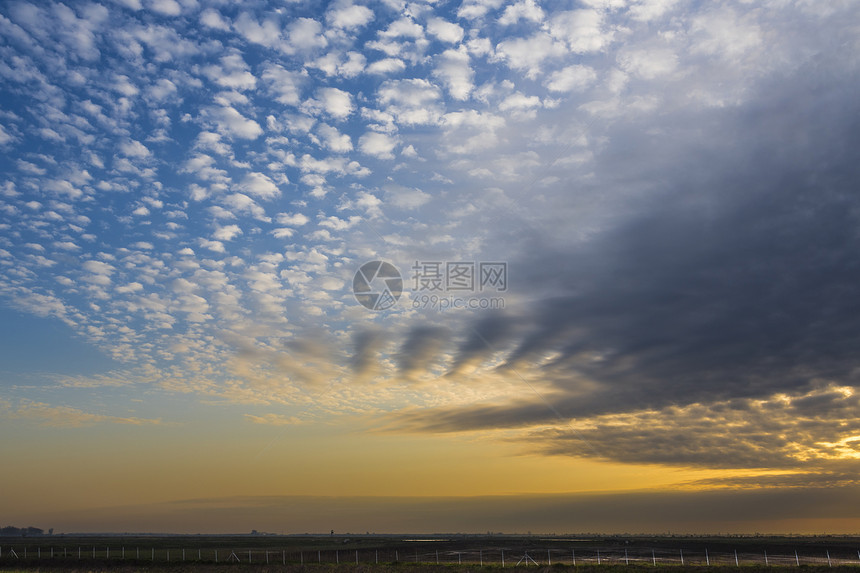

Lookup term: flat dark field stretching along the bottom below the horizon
[0,534,860,573]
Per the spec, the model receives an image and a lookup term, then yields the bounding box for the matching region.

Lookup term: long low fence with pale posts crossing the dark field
[0,544,860,568]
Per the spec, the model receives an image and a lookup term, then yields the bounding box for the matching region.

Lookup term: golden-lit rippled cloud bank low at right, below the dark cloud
[521,388,860,470]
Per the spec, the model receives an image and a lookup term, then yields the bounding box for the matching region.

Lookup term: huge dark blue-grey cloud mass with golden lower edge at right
[386,17,860,474]
